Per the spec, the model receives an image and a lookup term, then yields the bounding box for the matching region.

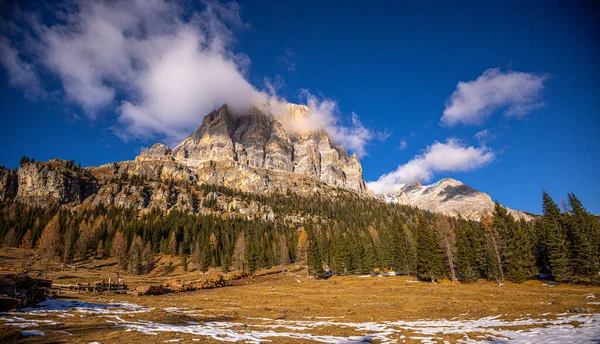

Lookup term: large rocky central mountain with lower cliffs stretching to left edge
[0,104,368,214]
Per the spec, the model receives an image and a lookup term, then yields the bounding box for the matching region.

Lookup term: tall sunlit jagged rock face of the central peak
[165,105,367,193]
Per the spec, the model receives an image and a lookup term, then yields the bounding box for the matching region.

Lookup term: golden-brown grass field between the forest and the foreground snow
[0,250,600,344]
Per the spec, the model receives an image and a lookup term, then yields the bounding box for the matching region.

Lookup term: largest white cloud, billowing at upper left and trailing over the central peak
[0,0,379,155]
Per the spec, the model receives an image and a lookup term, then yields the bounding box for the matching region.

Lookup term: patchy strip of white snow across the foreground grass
[0,300,600,343]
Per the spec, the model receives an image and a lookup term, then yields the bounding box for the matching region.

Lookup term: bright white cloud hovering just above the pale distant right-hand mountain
[367,138,495,194]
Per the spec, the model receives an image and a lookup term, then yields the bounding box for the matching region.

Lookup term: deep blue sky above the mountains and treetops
[0,1,600,213]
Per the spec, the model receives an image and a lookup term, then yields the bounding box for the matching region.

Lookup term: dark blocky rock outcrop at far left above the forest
[17,159,98,205]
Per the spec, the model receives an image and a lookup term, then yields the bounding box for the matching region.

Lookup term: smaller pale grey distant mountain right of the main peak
[383,178,533,221]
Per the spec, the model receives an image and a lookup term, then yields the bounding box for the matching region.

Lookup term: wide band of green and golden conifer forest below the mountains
[0,185,600,283]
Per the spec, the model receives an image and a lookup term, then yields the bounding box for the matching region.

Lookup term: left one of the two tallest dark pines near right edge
[541,191,573,282]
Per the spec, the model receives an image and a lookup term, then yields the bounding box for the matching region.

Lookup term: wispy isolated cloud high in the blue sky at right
[441,68,547,126]
